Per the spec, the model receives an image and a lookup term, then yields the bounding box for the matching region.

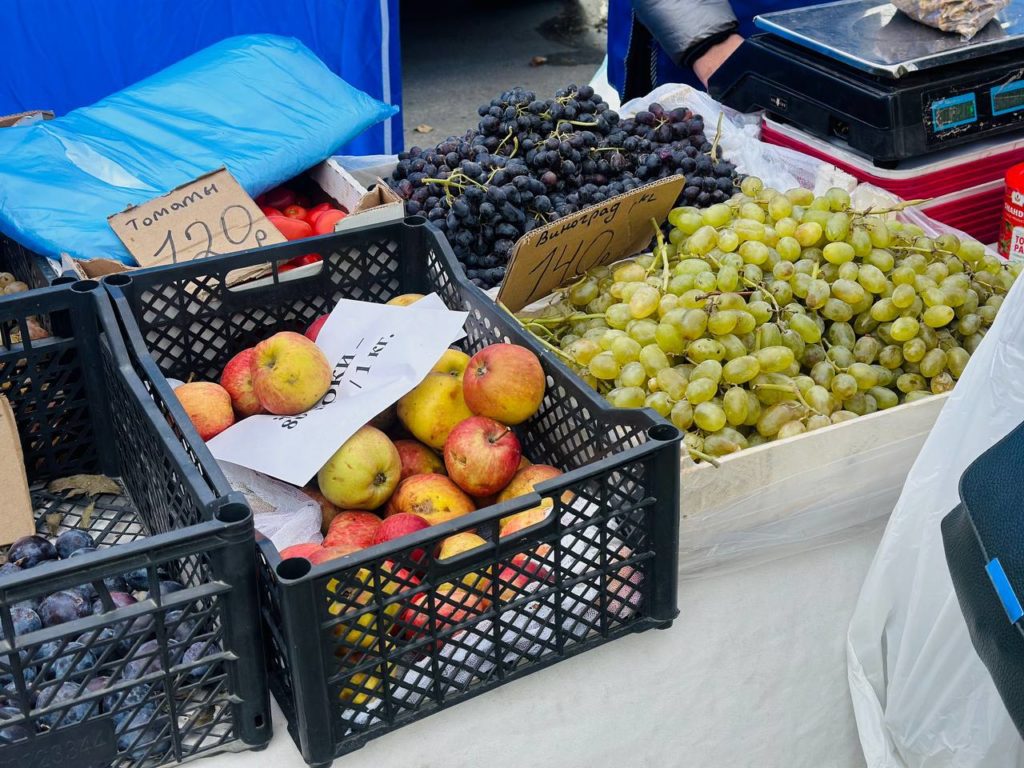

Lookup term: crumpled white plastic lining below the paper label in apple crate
[218,462,324,552]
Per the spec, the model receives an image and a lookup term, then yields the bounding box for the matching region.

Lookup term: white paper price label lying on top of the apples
[207,295,468,486]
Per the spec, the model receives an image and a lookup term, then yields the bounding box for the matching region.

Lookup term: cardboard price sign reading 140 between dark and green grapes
[498,176,685,312]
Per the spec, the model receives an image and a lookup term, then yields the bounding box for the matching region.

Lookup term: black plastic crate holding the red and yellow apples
[105,218,680,765]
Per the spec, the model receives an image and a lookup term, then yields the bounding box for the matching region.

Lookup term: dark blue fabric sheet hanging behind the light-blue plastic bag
[0,0,402,155]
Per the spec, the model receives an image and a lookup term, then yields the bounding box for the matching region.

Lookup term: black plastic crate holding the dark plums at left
[0,281,270,768]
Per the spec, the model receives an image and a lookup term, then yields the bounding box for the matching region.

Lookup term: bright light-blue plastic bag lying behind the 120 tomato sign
[0,35,396,264]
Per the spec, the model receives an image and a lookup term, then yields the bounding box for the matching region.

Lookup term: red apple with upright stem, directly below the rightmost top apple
[444,416,522,497]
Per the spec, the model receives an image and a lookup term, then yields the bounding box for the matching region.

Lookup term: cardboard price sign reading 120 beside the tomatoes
[108,168,285,267]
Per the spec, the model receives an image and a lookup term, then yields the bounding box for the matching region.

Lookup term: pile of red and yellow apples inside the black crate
[174,294,561,564]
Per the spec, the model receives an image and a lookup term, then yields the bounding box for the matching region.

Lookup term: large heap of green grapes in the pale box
[520,176,1019,461]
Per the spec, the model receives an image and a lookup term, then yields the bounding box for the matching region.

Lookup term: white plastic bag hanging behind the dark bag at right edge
[847,264,1024,768]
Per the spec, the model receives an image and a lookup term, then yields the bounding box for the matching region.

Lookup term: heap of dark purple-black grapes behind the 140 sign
[389,85,736,288]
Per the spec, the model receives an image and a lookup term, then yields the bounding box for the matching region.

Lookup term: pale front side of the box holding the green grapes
[679,394,948,578]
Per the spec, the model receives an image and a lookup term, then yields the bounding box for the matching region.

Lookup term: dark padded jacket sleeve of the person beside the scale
[633,0,737,67]
